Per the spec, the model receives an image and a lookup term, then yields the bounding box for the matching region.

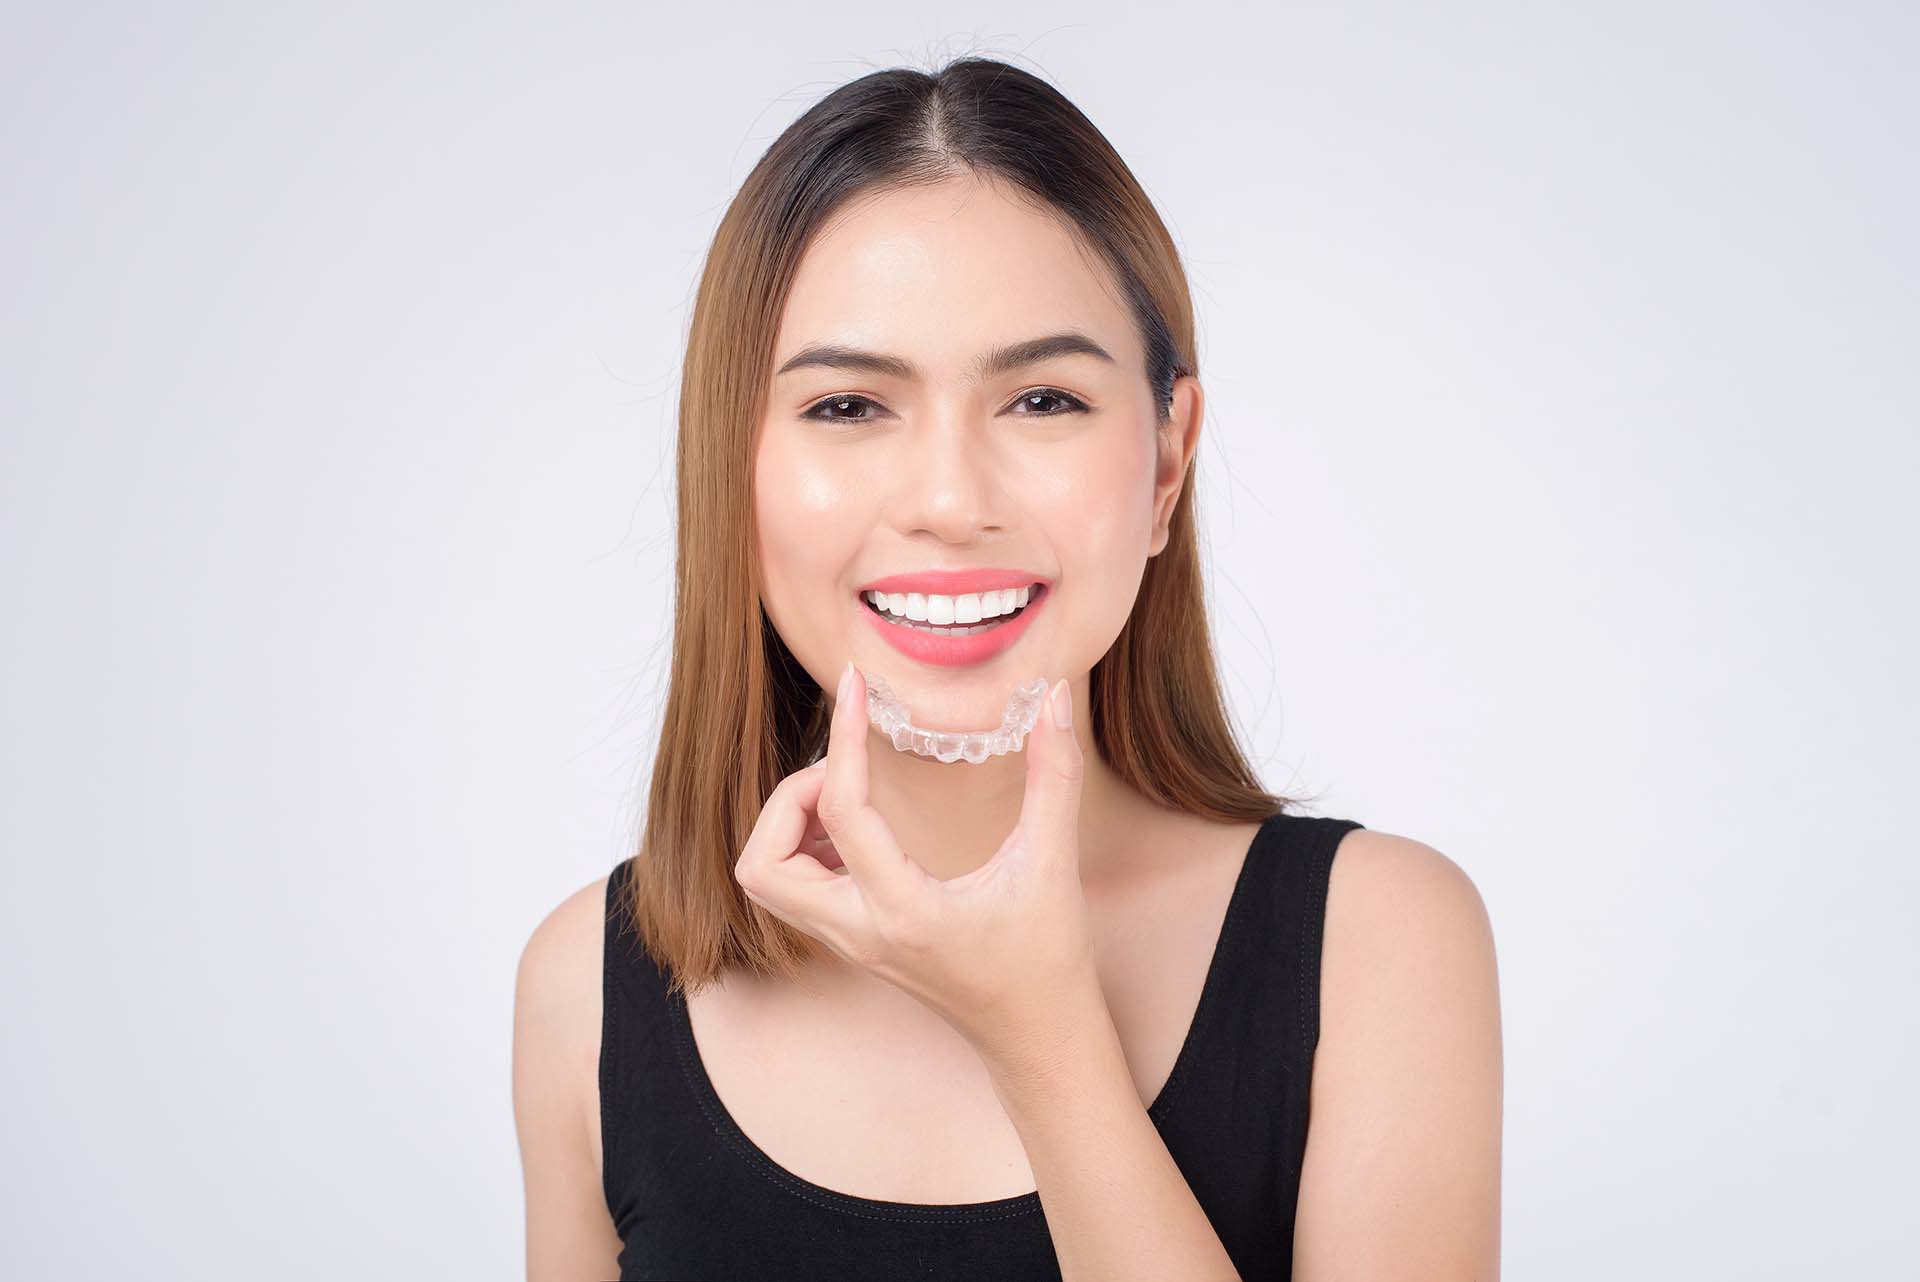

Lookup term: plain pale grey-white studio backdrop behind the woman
[0,0,1920,1280]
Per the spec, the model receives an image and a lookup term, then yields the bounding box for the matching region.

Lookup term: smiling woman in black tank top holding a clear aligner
[515,59,1501,1282]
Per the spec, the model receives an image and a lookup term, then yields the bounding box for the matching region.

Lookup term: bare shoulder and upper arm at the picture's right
[1294,829,1501,1282]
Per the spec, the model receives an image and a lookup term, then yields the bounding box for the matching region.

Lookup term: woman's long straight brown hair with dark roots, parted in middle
[620,58,1294,990]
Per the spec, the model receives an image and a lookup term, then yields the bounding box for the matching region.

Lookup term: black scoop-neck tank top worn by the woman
[599,814,1363,1282]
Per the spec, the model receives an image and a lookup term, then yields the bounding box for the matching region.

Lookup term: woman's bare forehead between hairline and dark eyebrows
[774,178,1131,374]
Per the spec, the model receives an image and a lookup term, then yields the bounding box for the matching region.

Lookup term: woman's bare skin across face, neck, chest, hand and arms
[515,172,1501,1282]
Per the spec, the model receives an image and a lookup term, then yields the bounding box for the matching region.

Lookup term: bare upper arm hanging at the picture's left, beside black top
[513,879,620,1282]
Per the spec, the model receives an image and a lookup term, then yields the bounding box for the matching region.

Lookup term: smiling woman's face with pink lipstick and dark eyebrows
[755,178,1198,740]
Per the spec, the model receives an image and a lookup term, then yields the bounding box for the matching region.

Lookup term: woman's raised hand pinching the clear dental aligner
[733,662,1098,1065]
